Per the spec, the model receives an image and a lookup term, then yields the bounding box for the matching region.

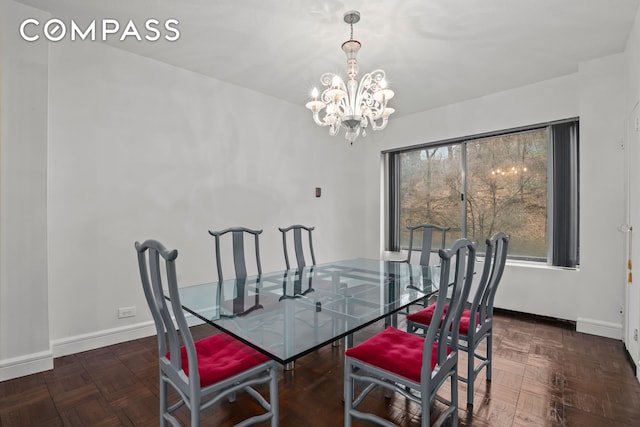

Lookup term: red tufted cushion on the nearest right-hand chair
[345,327,451,382]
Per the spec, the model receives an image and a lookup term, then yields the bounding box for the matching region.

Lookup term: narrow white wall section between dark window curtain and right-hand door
[576,54,627,338]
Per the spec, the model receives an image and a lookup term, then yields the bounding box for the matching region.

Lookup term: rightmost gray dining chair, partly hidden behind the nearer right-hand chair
[407,233,509,406]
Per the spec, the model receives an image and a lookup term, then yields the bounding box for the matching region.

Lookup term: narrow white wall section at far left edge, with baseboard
[0,1,53,381]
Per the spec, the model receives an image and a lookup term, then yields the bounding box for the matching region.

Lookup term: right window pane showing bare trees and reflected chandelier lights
[466,129,547,259]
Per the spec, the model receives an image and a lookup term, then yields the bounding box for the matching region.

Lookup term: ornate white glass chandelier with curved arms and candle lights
[306,10,395,144]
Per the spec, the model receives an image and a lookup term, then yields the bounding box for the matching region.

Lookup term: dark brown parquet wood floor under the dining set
[0,313,640,427]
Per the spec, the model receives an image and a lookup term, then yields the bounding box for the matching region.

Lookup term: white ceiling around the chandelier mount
[13,0,640,116]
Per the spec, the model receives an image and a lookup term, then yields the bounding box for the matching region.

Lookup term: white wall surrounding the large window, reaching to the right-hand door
[366,62,624,338]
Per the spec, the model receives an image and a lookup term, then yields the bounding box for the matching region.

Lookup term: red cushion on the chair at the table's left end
[167,333,269,387]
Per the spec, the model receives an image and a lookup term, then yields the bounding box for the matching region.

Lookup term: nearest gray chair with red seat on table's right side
[344,239,477,427]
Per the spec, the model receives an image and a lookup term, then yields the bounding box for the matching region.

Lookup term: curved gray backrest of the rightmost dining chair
[469,233,509,332]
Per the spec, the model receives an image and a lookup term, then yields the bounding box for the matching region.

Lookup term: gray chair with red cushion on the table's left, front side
[135,240,278,427]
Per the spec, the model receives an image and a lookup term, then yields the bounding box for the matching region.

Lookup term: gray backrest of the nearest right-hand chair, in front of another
[422,239,478,378]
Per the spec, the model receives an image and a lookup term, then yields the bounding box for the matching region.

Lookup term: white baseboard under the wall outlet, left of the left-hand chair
[51,320,156,357]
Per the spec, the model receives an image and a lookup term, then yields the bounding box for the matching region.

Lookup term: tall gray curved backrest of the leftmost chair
[135,240,200,396]
